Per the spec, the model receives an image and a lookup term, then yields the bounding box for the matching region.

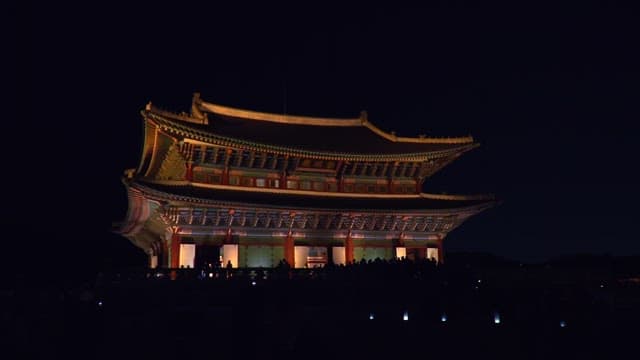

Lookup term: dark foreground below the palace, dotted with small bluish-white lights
[5,262,640,360]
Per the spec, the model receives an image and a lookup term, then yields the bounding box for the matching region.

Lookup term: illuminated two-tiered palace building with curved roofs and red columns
[117,93,495,268]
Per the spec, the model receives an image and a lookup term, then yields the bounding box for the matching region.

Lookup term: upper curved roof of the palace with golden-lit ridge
[145,94,478,157]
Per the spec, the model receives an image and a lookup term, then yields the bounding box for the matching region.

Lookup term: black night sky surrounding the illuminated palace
[13,1,640,272]
